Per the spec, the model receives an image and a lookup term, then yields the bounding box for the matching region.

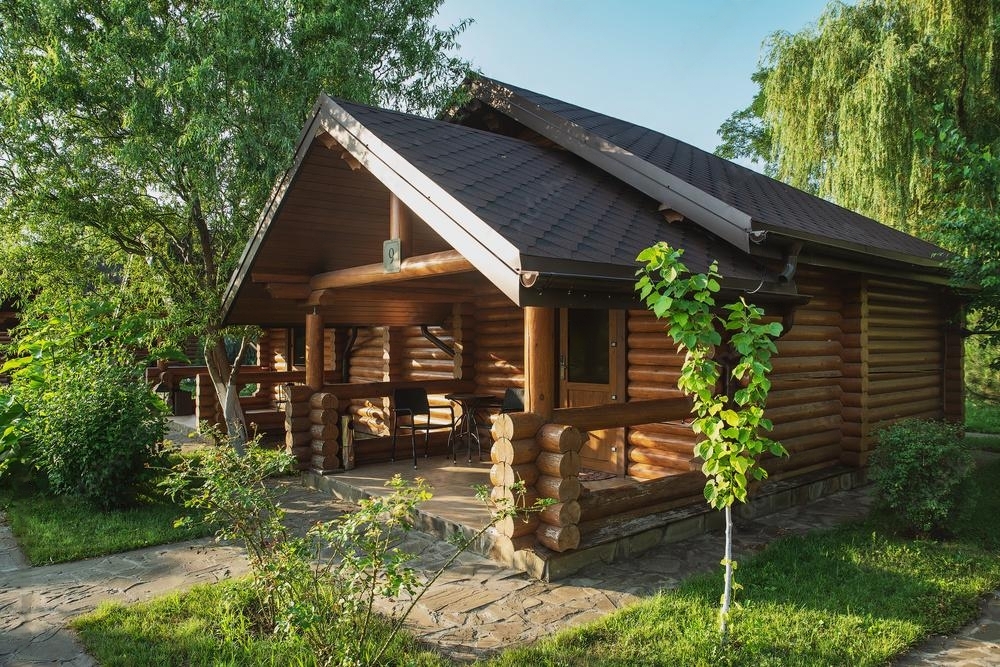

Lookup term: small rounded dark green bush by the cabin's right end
[870,419,973,533]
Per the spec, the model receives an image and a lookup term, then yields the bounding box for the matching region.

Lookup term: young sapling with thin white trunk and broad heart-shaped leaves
[636,242,786,641]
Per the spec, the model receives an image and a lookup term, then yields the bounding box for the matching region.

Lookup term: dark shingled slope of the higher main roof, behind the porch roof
[484,79,942,259]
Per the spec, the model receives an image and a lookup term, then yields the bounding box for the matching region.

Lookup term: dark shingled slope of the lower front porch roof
[338,100,761,281]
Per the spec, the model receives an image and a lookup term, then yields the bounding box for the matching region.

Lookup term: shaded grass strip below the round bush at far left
[0,478,212,565]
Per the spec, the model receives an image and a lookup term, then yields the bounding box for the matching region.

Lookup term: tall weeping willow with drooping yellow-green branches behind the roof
[717,0,1000,236]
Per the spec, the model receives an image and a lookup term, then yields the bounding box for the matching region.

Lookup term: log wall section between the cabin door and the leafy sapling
[625,310,700,479]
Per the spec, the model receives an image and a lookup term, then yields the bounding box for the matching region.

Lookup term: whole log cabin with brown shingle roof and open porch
[217,77,963,576]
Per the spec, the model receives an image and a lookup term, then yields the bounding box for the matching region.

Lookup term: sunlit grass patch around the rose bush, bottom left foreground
[72,580,450,667]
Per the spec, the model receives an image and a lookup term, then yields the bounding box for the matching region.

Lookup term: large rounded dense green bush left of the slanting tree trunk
[26,354,166,509]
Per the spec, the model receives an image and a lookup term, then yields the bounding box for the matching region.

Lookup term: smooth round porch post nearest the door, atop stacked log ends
[524,306,556,421]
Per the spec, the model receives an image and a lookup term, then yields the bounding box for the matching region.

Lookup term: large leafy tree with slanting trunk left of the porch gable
[0,0,465,446]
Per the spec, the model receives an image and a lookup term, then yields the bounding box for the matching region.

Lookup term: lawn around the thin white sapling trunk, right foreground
[490,464,1000,667]
